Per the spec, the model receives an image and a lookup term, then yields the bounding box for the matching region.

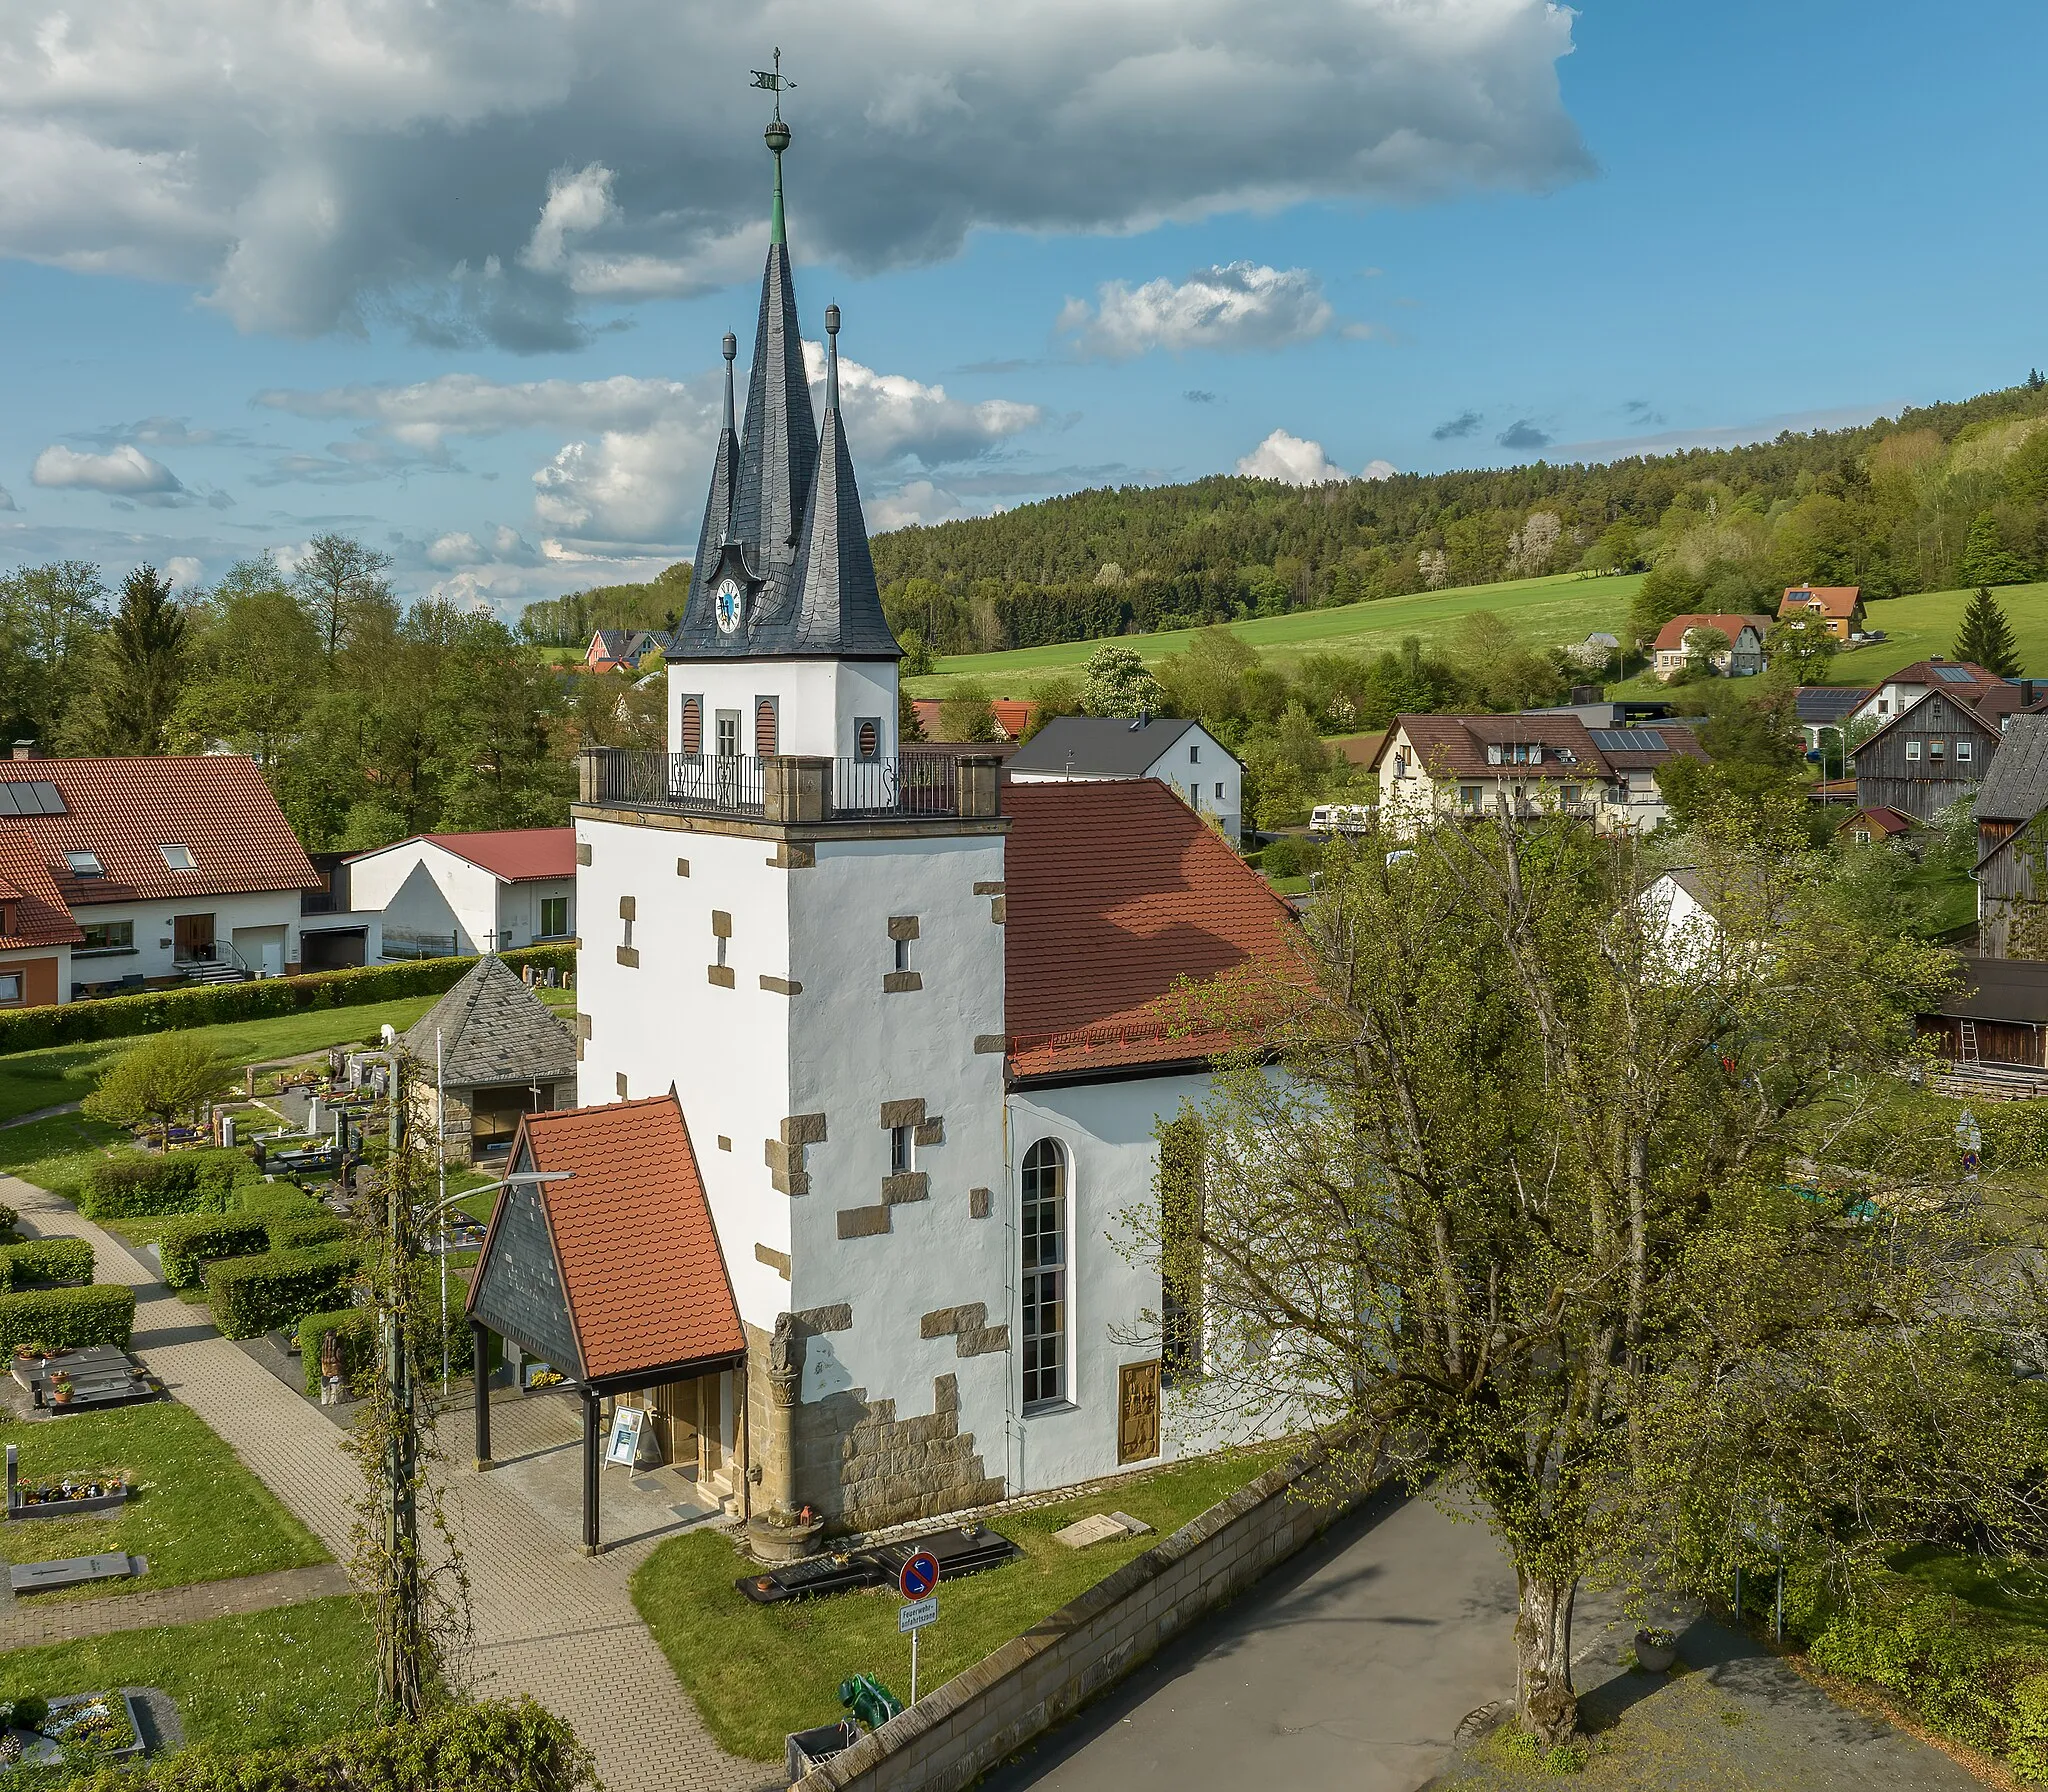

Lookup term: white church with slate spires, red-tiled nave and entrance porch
[471,104,1292,1530]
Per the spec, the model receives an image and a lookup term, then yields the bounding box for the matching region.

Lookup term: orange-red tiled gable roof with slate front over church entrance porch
[469,1094,748,1382]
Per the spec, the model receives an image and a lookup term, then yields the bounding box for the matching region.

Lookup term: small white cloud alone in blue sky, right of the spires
[1055,262,1335,360]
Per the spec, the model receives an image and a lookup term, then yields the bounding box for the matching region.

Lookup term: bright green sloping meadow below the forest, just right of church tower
[903,573,1642,696]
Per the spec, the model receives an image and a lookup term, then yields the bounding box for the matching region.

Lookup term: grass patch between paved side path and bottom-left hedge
[0,1595,375,1749]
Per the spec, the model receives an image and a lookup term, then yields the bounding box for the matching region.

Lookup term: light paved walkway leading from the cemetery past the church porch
[0,1178,780,1792]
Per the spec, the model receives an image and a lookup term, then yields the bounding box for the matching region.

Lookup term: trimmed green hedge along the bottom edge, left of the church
[49,1698,598,1792]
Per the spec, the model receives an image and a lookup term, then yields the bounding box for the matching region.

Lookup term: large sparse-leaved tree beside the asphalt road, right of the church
[1155,817,2040,1747]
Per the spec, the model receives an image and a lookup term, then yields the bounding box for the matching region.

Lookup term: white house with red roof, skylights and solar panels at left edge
[0,754,319,1001]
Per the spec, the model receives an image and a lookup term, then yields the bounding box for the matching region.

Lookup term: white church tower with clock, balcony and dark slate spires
[573,98,1014,1528]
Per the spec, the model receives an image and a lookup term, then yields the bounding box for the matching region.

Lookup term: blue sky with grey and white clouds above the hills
[0,0,2048,614]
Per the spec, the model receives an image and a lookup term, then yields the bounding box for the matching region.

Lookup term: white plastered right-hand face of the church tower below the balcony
[782,834,1010,1441]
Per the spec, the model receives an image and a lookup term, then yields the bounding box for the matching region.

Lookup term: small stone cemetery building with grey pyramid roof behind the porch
[406,952,575,1163]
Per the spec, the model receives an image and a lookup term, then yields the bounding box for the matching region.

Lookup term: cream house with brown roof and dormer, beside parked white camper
[1372,711,1706,838]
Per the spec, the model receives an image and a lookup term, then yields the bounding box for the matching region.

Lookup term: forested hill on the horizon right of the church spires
[874,373,2048,653]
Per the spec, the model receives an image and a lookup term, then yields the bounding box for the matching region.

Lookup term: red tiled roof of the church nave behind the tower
[1004,778,1294,1077]
